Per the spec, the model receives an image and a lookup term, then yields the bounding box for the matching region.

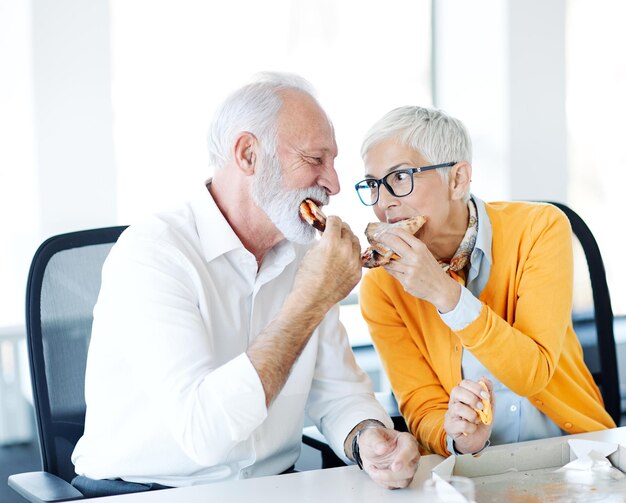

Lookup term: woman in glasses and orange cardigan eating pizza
[356,107,615,455]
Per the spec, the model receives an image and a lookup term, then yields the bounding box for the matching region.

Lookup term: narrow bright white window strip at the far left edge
[0,0,39,325]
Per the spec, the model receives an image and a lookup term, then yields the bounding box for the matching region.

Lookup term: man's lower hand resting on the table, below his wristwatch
[359,427,420,489]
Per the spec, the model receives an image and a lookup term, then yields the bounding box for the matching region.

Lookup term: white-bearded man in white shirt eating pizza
[72,74,419,496]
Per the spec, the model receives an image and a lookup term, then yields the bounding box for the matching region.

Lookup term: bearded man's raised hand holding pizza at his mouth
[294,216,361,314]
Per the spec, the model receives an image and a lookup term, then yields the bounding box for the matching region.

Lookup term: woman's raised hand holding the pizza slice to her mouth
[370,229,461,313]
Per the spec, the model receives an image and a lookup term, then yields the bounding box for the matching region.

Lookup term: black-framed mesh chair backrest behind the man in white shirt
[26,227,126,482]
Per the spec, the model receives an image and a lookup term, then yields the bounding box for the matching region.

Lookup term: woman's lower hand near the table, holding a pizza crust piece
[443,378,495,454]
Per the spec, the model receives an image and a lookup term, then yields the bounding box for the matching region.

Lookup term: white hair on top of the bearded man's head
[208,72,315,169]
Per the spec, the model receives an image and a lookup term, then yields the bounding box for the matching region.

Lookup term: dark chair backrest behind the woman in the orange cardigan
[548,201,621,426]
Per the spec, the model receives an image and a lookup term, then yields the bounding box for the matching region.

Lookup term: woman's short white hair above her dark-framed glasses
[361,106,472,186]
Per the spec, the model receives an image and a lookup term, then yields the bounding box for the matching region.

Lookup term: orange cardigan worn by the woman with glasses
[360,202,615,456]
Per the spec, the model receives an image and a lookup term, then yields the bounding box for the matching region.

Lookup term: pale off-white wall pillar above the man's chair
[32,0,117,232]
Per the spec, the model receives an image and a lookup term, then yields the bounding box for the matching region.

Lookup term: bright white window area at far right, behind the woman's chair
[566,0,626,315]
